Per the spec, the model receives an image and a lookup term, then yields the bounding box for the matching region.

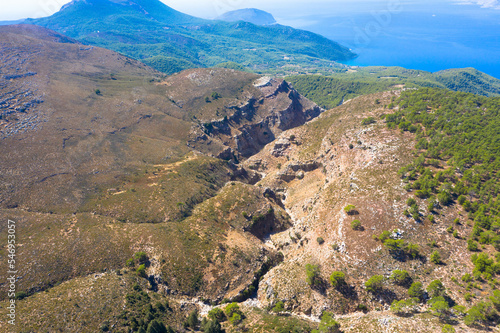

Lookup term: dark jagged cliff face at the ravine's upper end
[189,77,324,159]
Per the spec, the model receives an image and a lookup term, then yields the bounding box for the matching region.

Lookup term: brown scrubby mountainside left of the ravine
[0,25,323,326]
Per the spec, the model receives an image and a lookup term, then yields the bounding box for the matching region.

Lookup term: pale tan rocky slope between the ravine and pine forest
[243,92,478,324]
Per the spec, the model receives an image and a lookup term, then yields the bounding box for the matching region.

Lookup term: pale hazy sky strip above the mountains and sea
[0,0,500,20]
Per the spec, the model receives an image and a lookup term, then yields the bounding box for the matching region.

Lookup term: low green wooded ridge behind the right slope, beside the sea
[286,66,500,108]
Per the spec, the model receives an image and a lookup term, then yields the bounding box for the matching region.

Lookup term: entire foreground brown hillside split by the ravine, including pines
[0,25,500,333]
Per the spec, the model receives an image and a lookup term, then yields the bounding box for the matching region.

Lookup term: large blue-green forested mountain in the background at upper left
[26,0,355,73]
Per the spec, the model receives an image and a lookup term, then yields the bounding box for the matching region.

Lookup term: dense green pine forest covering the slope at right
[385,89,500,275]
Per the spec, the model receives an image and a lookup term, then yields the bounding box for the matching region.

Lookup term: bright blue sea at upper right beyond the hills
[276,0,500,78]
